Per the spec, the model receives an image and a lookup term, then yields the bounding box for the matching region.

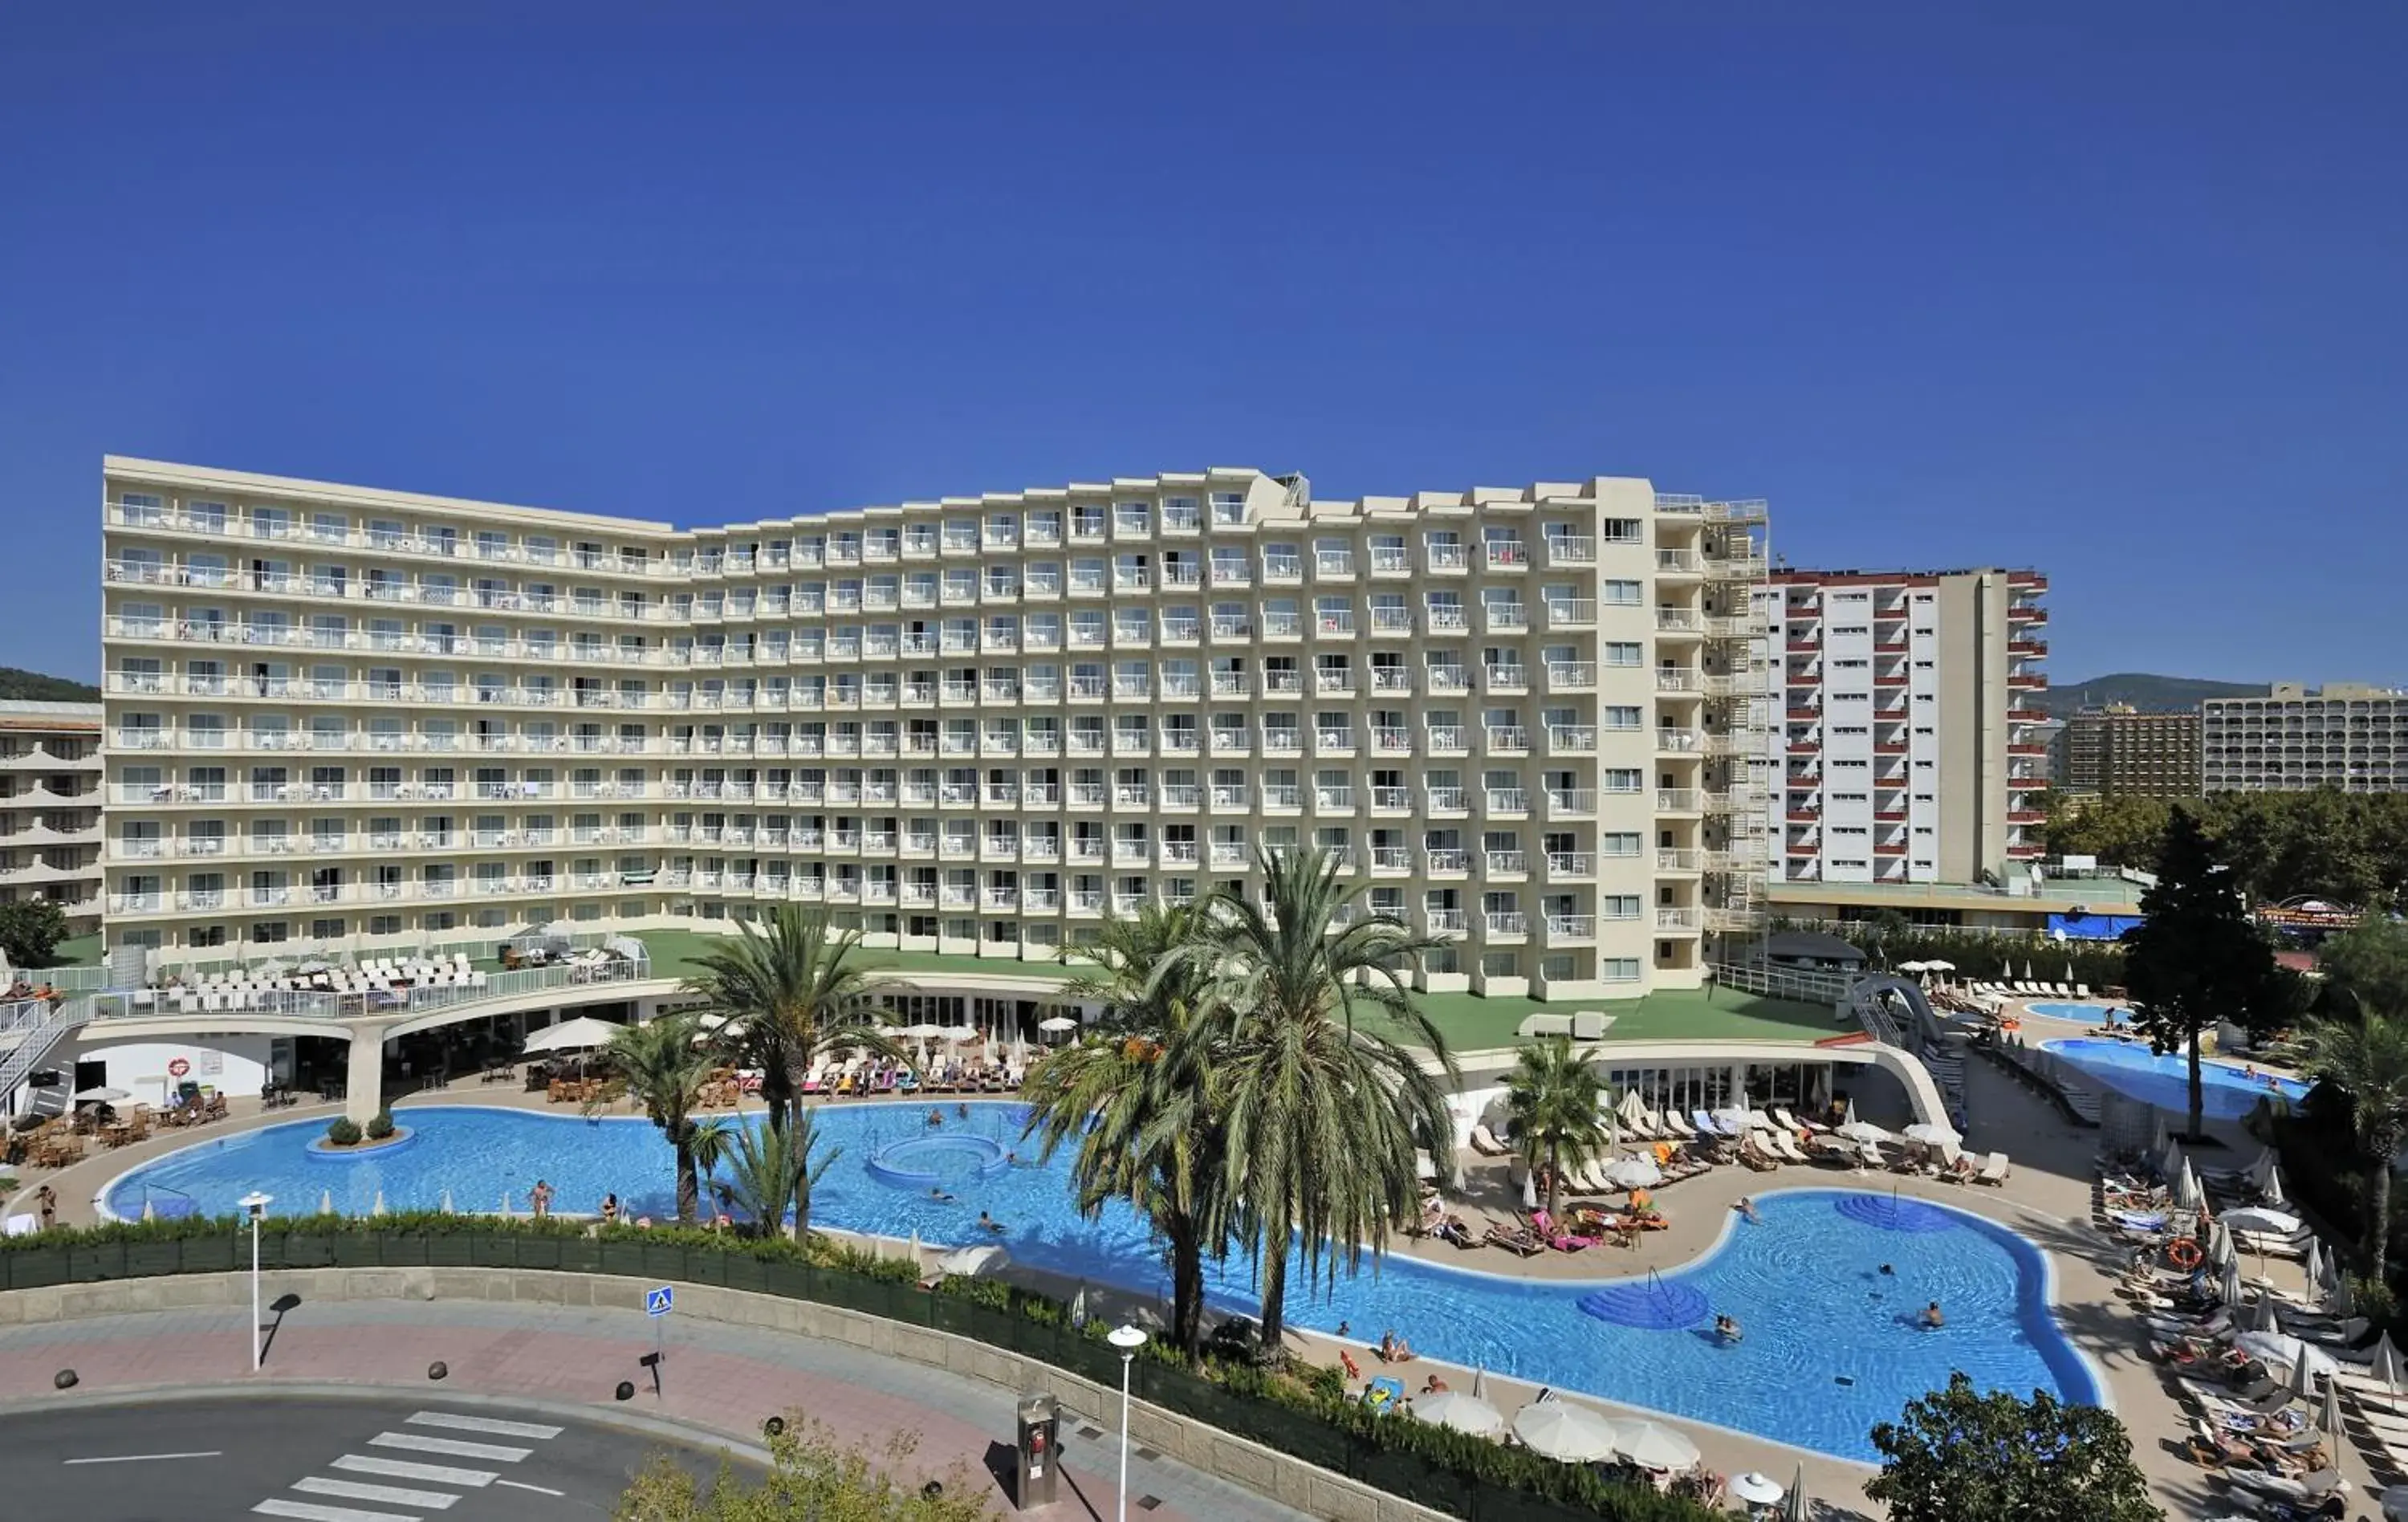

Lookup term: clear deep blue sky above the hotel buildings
[0,2,2408,679]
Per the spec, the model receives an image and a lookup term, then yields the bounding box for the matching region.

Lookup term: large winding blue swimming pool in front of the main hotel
[106,1103,2100,1459]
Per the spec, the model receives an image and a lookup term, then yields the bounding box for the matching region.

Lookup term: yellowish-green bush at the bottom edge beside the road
[612,1411,995,1522]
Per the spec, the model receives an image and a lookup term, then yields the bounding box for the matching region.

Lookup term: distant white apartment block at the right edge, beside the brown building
[2199,682,2408,792]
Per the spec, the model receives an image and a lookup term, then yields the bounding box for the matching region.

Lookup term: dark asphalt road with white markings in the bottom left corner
[0,1392,742,1522]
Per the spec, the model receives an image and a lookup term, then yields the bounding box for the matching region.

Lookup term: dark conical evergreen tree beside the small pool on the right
[2124,809,2288,1139]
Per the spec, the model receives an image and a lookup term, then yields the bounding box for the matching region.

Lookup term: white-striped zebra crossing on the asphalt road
[250,1411,561,1522]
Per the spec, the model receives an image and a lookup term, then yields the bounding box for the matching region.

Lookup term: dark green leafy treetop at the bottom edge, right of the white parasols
[1864,1373,2165,1522]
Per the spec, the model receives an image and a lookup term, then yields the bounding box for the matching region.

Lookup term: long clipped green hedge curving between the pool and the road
[0,1211,1714,1522]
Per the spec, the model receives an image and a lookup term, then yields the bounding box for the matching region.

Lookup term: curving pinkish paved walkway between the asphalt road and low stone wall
[0,1300,1303,1522]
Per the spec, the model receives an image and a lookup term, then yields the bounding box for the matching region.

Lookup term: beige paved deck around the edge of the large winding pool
[5,1050,2312,1517]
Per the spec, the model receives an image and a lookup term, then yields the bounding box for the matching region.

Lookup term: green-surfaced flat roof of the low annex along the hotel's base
[641,930,1847,1052]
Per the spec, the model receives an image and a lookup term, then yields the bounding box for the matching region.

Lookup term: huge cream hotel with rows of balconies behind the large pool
[104,458,1767,999]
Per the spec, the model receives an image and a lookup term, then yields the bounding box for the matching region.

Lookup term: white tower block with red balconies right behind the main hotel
[1758,568,2049,884]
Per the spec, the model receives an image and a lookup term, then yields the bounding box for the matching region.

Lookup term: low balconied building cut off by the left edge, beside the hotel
[0,701,101,934]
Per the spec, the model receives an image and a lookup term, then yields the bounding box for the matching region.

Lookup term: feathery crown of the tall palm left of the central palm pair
[686,903,901,1117]
